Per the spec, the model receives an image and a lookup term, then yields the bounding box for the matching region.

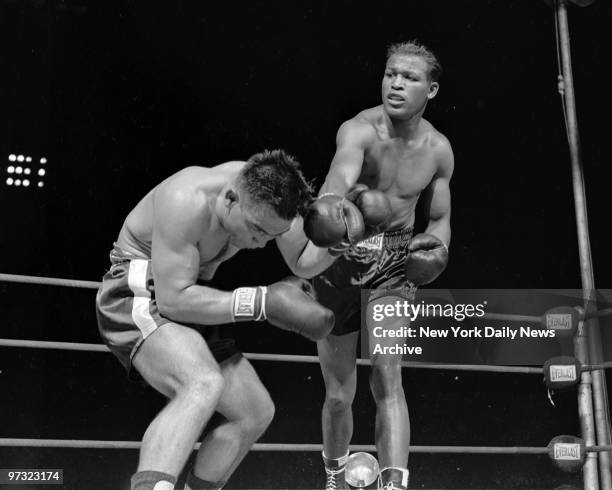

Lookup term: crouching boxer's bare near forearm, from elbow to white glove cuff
[157,284,233,325]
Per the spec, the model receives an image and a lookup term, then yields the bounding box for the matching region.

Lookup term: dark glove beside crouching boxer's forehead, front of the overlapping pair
[304,194,365,247]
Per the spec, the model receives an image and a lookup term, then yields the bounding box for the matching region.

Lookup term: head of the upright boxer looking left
[382,42,442,119]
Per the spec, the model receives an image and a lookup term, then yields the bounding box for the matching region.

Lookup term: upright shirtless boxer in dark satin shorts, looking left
[279,42,454,489]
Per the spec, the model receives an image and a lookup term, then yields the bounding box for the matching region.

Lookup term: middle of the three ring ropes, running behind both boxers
[0,339,543,374]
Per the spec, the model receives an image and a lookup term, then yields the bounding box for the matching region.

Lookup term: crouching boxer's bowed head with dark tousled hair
[223,150,312,248]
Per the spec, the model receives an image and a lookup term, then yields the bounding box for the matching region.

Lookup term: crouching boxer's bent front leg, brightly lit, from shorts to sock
[133,323,224,476]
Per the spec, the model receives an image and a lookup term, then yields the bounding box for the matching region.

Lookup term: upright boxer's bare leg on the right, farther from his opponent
[366,298,410,468]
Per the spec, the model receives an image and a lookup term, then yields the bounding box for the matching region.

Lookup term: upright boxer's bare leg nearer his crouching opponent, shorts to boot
[317,332,359,459]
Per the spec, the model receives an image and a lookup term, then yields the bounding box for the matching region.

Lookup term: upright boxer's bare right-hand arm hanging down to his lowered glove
[423,138,455,245]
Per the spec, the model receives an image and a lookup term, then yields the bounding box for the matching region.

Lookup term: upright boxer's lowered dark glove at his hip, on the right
[404,233,448,286]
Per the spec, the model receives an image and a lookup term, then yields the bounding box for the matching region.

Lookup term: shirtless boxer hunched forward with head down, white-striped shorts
[96,150,333,490]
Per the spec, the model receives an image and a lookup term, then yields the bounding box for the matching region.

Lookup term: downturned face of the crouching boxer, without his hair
[225,194,291,248]
